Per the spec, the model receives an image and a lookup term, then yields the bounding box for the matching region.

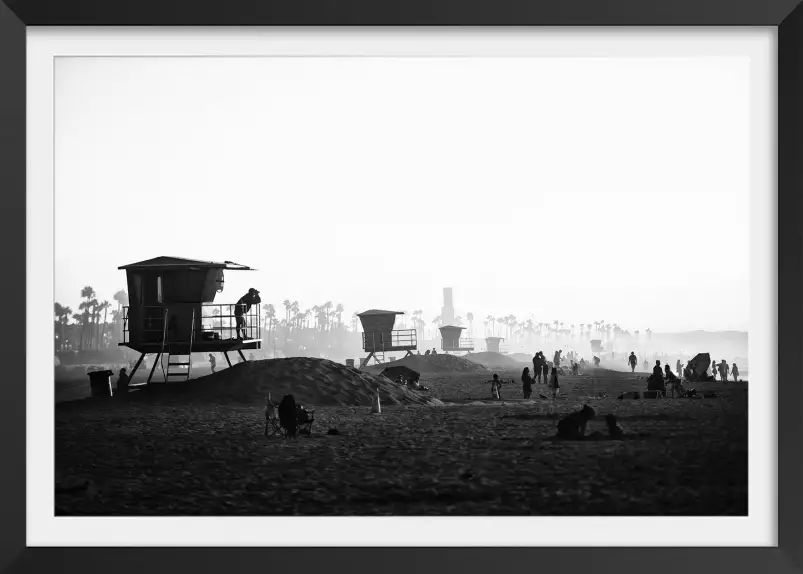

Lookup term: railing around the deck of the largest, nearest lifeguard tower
[123,303,262,343]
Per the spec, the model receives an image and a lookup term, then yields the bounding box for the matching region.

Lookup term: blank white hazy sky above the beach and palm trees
[55,58,749,332]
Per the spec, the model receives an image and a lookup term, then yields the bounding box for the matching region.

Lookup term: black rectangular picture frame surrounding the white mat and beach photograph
[0,0,803,574]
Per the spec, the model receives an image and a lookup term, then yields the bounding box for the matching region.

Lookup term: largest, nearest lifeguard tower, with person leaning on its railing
[118,257,262,383]
